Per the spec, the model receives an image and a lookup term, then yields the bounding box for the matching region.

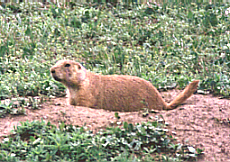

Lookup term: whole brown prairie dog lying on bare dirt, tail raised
[50,60,199,111]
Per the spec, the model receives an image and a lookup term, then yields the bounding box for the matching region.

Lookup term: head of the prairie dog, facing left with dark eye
[50,60,86,86]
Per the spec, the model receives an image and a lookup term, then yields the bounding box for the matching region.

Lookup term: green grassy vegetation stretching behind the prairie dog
[0,3,230,99]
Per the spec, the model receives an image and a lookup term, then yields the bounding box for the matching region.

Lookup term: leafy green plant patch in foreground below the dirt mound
[0,116,203,162]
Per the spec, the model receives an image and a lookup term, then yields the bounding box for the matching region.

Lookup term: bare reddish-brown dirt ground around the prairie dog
[0,90,230,162]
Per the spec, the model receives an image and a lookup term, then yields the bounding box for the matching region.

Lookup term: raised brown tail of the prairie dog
[166,80,199,110]
